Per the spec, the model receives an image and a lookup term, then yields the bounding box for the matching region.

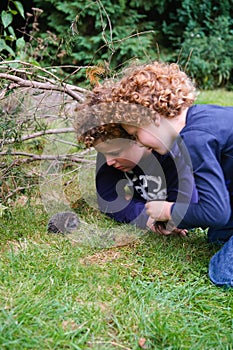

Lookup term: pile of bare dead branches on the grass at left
[0,61,93,202]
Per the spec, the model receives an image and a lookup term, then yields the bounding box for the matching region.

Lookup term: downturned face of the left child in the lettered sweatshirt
[95,138,150,172]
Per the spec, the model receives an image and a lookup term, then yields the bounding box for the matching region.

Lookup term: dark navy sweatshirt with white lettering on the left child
[96,146,197,228]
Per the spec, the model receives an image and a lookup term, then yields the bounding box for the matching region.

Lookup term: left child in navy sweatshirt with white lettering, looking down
[76,122,196,236]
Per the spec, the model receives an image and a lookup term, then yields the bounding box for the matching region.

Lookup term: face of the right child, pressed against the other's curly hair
[122,122,175,154]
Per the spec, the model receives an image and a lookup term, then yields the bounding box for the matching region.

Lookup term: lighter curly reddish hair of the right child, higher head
[93,61,196,118]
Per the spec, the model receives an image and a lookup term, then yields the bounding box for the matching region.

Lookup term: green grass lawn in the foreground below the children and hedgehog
[0,92,233,350]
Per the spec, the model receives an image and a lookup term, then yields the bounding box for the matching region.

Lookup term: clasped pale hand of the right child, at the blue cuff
[145,201,173,221]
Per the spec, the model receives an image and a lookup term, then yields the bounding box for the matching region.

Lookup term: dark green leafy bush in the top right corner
[163,0,233,89]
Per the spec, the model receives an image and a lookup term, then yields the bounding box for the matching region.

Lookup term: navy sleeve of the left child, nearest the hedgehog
[96,153,148,228]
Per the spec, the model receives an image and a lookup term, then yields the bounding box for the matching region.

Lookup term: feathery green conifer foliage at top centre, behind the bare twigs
[31,0,157,75]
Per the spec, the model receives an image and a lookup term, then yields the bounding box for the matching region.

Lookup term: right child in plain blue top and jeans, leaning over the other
[78,62,233,286]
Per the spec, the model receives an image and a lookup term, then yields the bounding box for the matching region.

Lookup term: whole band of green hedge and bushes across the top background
[0,0,233,89]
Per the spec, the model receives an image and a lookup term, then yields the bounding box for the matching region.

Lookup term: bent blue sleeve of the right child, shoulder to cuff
[172,130,231,228]
